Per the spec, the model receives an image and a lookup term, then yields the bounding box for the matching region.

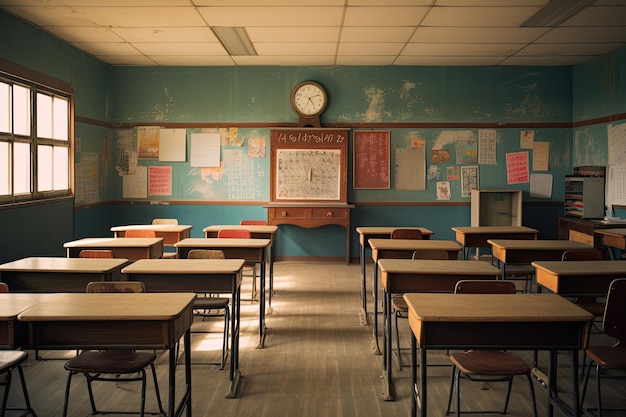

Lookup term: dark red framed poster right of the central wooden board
[352,130,391,189]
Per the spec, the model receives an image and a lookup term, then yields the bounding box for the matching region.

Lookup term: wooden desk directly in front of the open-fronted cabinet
[452,226,539,259]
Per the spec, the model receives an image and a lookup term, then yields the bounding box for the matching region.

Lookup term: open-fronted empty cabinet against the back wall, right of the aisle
[471,190,522,227]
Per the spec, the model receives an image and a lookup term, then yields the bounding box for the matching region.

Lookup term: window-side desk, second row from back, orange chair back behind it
[63,237,163,261]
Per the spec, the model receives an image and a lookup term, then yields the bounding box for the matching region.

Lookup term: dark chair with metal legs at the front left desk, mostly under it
[63,281,165,417]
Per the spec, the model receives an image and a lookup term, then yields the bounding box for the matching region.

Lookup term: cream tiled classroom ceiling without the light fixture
[0,0,626,66]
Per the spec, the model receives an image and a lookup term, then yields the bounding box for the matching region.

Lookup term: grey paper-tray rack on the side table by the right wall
[564,176,604,219]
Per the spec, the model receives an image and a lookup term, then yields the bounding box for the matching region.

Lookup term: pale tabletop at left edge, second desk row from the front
[0,257,128,273]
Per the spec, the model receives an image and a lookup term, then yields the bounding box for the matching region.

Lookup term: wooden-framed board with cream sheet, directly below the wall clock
[270,129,348,203]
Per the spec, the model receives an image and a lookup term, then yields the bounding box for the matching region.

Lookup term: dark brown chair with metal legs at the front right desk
[446,280,537,417]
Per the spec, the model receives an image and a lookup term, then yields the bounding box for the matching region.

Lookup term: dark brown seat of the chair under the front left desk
[65,350,156,374]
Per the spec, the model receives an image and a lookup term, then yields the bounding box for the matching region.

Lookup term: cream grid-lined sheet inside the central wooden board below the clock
[276,149,341,200]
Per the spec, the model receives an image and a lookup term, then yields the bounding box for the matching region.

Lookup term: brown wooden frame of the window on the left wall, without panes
[0,58,75,207]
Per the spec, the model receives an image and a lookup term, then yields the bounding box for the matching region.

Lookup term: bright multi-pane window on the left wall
[0,72,72,204]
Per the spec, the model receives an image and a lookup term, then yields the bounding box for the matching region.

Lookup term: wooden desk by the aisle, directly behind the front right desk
[378,259,502,401]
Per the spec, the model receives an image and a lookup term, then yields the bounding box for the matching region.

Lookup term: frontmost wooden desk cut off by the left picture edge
[0,293,48,349]
